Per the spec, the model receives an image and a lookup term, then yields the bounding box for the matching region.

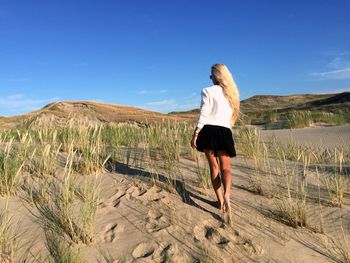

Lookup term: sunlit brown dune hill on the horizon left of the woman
[0,101,194,129]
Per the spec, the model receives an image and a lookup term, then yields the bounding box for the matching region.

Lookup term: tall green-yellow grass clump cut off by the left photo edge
[0,138,24,196]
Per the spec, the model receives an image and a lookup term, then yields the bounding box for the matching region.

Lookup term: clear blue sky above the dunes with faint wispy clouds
[0,0,350,116]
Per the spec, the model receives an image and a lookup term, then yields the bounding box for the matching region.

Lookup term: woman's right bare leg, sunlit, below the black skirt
[218,151,232,213]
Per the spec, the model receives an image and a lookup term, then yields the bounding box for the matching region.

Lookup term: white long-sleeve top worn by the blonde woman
[197,85,233,129]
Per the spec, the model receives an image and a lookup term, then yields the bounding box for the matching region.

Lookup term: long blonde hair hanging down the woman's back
[211,64,240,125]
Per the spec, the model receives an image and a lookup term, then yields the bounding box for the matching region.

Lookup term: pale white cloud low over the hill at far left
[0,94,58,116]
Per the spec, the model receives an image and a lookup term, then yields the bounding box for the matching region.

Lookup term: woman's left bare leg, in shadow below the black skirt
[204,150,224,210]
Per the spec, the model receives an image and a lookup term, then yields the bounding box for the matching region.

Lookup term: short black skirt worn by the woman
[197,124,236,157]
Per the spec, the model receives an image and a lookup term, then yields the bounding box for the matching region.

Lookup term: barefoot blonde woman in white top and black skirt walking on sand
[191,64,240,217]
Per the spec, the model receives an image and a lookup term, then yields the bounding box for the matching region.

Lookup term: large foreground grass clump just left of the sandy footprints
[31,147,98,244]
